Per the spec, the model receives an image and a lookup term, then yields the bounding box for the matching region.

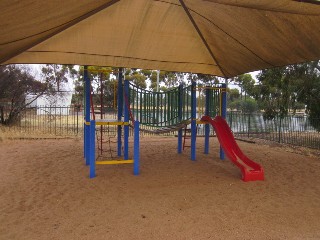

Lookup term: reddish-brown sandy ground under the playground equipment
[0,137,320,240]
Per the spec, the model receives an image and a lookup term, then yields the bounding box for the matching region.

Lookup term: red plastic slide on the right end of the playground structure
[201,116,264,182]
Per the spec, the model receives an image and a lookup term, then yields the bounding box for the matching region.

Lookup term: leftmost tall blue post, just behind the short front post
[83,66,91,166]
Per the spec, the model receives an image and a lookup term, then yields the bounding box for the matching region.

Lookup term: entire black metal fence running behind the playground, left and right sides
[1,106,320,149]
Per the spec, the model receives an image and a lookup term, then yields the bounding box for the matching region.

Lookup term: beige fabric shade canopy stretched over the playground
[0,0,320,77]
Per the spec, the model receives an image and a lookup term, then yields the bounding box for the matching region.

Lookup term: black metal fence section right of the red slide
[227,112,320,149]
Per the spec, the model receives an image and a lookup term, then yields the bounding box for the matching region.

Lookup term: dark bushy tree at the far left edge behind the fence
[0,65,46,125]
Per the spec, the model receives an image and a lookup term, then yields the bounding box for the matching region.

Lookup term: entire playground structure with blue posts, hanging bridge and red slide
[84,66,264,181]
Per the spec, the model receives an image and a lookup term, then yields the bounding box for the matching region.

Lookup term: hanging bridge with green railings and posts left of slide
[125,82,226,161]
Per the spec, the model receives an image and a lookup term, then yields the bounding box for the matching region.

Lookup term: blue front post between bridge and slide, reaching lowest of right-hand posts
[191,81,197,161]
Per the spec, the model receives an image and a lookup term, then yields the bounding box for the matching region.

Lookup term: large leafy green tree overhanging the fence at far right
[233,61,320,130]
